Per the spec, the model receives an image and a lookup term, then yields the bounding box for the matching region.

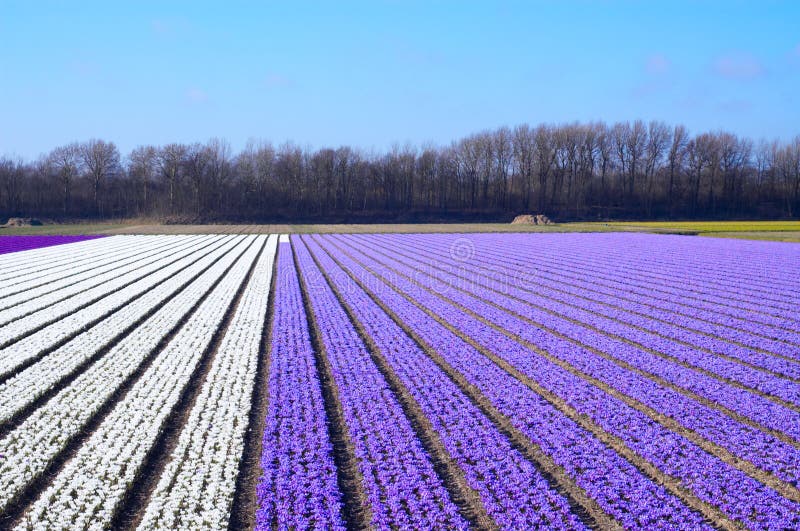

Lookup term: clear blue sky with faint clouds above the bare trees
[0,0,800,158]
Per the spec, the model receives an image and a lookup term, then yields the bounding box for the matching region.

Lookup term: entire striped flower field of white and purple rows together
[0,233,800,530]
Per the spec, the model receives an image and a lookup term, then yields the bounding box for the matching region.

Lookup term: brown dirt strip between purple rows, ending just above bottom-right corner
[324,237,800,512]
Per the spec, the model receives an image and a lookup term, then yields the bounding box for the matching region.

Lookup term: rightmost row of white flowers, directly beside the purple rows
[139,236,277,530]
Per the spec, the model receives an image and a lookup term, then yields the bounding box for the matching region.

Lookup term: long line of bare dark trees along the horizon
[0,121,800,222]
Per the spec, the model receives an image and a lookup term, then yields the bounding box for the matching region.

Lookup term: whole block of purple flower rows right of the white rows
[257,235,800,529]
